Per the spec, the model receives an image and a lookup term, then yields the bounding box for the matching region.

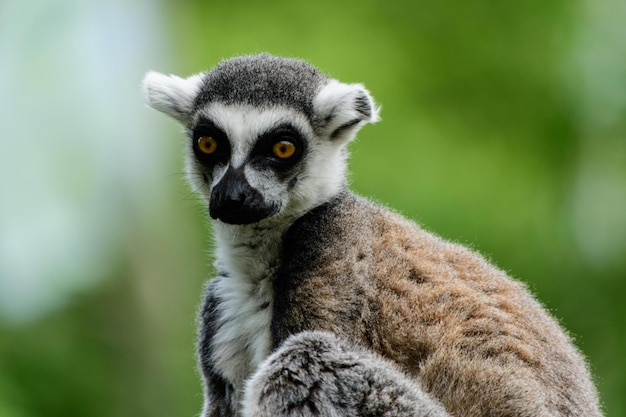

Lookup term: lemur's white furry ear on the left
[143,72,204,124]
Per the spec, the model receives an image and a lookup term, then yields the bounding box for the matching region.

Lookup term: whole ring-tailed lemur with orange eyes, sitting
[143,54,602,417]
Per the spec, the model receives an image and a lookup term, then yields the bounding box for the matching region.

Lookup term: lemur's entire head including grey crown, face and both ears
[143,54,378,224]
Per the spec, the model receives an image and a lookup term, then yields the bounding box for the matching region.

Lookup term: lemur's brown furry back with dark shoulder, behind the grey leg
[272,193,601,416]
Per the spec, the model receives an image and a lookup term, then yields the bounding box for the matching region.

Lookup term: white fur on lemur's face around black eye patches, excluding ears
[188,103,352,221]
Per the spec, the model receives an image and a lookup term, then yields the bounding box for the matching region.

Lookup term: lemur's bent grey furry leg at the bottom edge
[242,331,450,417]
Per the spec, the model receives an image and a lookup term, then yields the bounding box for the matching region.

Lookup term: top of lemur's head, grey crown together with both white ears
[143,54,378,133]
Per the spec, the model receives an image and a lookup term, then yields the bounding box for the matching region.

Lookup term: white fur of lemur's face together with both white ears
[143,72,379,226]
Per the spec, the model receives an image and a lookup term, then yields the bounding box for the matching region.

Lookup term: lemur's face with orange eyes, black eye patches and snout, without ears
[187,103,312,224]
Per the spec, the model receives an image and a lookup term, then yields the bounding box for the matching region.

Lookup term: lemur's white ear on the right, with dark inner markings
[313,80,380,143]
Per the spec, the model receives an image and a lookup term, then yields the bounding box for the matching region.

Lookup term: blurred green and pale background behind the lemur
[0,0,626,417]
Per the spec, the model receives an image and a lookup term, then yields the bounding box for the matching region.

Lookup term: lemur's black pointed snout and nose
[209,167,276,224]
